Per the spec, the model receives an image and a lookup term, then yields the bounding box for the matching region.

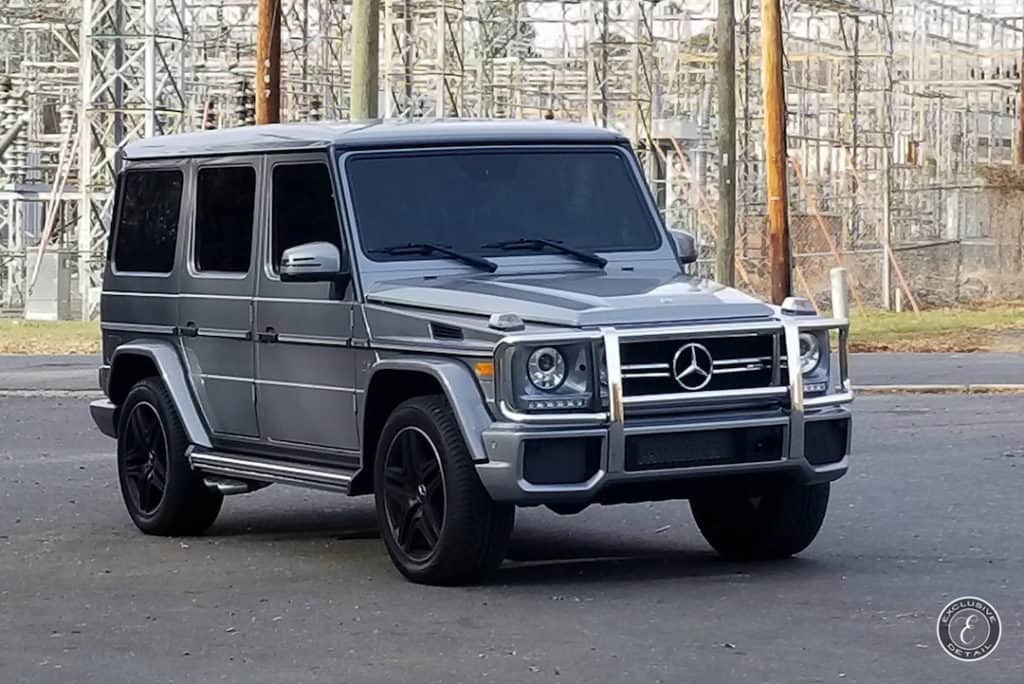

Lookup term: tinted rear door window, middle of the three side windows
[196,166,256,273]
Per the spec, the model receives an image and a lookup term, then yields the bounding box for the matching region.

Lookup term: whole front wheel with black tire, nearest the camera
[374,395,515,585]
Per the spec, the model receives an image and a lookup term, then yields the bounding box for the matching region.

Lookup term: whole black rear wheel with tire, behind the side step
[118,378,223,537]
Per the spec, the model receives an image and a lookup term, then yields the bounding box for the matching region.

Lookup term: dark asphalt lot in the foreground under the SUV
[0,395,1024,684]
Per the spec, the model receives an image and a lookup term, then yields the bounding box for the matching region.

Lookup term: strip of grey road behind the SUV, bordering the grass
[0,352,1024,392]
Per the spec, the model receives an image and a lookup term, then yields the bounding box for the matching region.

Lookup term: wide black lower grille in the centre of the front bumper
[626,425,785,470]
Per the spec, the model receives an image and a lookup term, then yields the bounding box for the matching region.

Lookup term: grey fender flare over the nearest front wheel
[362,356,494,463]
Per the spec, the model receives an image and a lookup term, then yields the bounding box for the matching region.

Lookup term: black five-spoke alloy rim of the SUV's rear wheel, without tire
[124,401,168,516]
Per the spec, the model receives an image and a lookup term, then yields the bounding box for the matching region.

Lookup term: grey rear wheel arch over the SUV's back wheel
[106,340,212,447]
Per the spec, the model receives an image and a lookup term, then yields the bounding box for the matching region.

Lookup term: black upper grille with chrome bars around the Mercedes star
[621,334,776,396]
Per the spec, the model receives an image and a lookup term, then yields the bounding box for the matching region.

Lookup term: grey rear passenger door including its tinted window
[179,157,262,438]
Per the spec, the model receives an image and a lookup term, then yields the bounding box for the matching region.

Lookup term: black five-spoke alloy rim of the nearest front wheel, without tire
[383,426,445,563]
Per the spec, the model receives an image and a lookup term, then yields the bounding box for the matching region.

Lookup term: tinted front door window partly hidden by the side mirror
[270,164,341,272]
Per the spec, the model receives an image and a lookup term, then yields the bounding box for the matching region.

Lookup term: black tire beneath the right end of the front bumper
[690,482,829,560]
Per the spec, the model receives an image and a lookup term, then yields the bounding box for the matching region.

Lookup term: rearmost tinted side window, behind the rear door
[114,170,181,273]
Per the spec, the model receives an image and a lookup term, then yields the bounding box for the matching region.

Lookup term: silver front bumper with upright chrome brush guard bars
[476,320,853,506]
